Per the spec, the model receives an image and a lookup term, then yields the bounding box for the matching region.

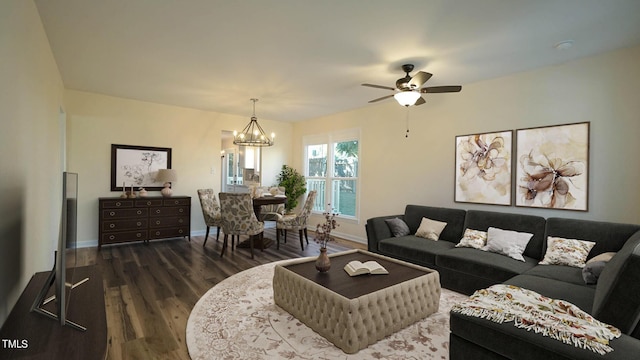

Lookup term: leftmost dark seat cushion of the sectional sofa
[378,235,455,266]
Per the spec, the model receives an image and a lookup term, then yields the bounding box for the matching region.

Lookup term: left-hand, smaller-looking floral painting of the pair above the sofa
[454,130,513,206]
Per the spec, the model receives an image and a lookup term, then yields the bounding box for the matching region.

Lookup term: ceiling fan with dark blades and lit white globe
[362,64,462,106]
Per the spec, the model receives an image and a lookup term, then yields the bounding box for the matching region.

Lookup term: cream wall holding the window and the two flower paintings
[293,47,640,241]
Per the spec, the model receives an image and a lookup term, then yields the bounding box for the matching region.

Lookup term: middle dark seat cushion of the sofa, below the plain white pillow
[436,248,538,283]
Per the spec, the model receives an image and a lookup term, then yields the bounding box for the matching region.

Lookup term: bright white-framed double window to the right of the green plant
[304,130,360,219]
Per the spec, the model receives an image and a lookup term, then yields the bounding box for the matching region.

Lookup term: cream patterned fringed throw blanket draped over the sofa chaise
[451,285,620,355]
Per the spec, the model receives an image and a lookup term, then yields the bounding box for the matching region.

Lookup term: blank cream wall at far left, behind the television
[0,0,63,324]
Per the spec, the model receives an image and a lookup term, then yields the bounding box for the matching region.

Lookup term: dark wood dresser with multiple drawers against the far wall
[98,196,191,248]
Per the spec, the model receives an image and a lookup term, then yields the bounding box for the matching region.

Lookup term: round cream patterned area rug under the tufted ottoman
[187,260,468,360]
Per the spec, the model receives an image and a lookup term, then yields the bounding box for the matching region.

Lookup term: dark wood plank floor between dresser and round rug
[78,229,365,359]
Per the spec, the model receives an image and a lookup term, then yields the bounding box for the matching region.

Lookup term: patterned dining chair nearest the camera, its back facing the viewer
[218,193,264,259]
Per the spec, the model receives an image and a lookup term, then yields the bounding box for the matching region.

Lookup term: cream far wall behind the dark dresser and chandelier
[65,90,292,245]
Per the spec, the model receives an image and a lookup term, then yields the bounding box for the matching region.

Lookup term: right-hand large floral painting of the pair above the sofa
[516,122,589,211]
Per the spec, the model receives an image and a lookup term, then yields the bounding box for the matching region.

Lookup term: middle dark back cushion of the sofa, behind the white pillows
[464,210,546,261]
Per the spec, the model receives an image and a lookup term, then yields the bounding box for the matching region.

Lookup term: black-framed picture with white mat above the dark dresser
[111,144,171,191]
